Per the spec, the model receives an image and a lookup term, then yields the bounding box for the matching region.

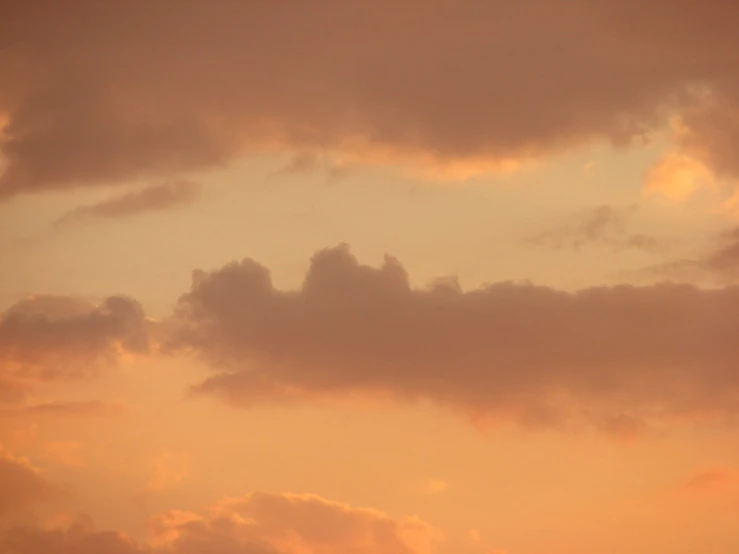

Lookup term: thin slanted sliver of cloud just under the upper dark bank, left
[56,181,200,226]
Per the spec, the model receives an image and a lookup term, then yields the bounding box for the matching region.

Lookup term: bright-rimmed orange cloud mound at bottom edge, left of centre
[151,493,440,554]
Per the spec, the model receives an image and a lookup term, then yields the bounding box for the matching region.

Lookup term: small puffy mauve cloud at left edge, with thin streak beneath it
[0,296,153,421]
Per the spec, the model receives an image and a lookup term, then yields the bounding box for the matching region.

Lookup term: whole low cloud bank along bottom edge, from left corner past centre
[0,493,440,554]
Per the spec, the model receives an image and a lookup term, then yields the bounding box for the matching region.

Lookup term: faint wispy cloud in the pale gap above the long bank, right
[527,204,664,252]
